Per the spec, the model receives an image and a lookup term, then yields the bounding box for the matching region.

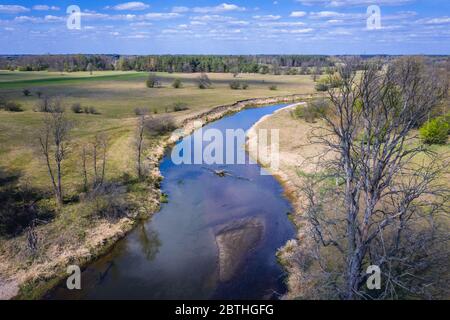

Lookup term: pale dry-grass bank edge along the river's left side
[0,93,314,300]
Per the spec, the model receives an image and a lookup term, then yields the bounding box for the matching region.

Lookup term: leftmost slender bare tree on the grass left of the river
[39,102,71,207]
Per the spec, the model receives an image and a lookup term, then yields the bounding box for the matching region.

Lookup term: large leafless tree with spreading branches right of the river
[298,57,449,299]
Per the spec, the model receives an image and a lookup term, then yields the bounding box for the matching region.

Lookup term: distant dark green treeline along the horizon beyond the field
[0,54,335,74]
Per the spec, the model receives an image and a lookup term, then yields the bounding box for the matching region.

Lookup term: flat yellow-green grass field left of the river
[0,71,314,191]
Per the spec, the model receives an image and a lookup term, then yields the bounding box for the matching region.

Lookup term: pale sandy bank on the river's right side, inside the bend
[247,104,328,299]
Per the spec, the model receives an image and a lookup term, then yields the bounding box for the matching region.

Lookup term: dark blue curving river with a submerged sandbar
[48,105,294,299]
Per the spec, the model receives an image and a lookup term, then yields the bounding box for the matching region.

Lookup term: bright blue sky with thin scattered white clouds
[0,0,450,54]
